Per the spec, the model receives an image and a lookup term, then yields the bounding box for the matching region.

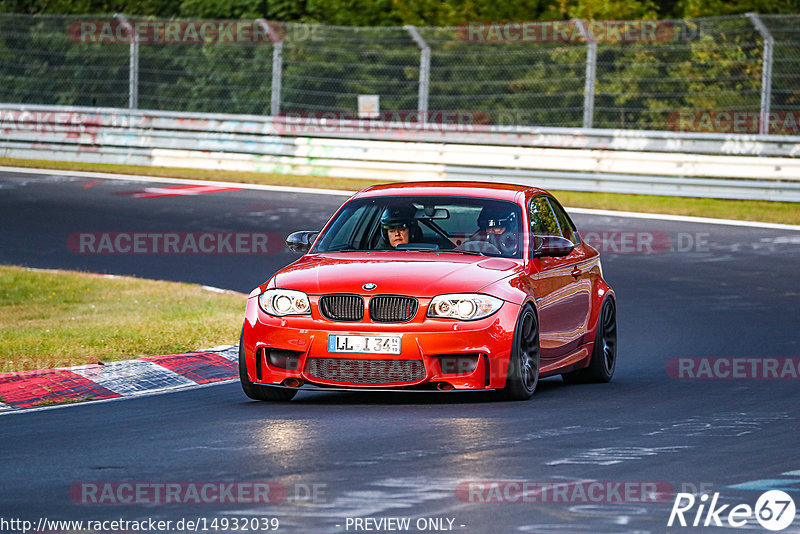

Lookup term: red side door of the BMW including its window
[528,194,593,366]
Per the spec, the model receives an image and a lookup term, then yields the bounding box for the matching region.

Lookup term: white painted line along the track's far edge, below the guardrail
[0,166,800,231]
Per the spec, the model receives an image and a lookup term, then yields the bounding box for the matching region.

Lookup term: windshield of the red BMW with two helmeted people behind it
[311,196,522,258]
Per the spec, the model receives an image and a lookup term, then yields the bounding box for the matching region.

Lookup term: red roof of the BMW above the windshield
[355,182,545,201]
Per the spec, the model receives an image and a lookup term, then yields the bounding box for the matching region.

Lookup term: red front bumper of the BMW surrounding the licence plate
[244,298,520,391]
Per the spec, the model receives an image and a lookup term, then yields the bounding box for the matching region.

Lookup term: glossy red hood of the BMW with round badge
[273,252,522,297]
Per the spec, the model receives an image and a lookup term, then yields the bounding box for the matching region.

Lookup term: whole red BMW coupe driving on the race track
[239,182,617,401]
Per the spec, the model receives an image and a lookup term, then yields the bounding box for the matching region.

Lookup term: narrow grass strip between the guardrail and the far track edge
[0,158,800,224]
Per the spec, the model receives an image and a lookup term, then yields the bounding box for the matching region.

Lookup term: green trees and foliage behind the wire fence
[0,0,800,129]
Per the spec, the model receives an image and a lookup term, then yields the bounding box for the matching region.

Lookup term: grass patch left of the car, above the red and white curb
[0,266,246,372]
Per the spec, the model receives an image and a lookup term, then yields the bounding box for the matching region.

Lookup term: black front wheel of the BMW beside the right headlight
[502,304,541,400]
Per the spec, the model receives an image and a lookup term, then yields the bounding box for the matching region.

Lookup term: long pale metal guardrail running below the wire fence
[0,104,800,202]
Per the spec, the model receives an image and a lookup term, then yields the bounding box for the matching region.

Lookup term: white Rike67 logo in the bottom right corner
[667,490,795,532]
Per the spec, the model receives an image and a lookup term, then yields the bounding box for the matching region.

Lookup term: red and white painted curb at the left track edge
[0,345,239,413]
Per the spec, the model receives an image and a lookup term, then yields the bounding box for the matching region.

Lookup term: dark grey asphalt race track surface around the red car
[0,172,800,534]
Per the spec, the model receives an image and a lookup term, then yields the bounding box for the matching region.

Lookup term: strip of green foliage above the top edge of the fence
[6,0,800,20]
